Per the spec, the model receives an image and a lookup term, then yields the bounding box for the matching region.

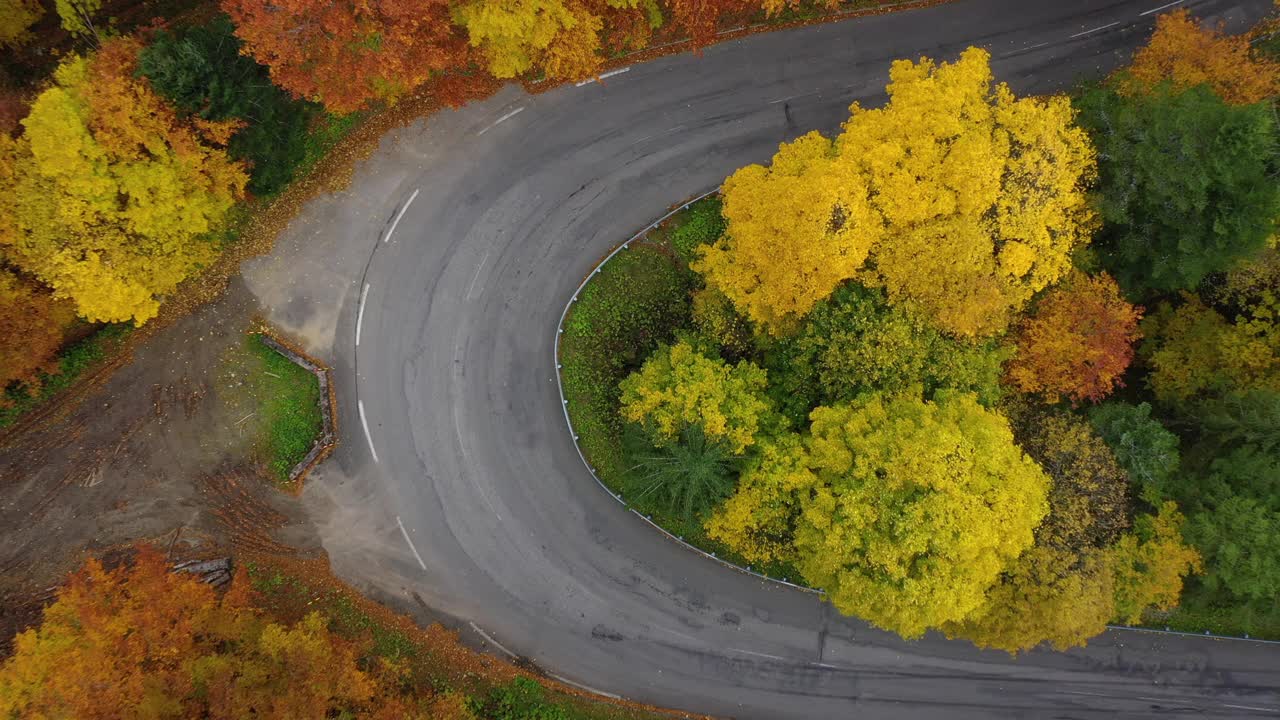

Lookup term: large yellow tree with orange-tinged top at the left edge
[0,38,247,323]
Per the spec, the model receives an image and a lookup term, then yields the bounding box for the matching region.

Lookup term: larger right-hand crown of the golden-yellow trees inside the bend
[836,47,1094,336]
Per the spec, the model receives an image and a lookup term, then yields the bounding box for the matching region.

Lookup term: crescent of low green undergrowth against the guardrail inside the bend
[561,243,690,482]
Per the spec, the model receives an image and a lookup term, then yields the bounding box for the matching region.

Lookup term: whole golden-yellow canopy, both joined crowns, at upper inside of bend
[692,47,1094,337]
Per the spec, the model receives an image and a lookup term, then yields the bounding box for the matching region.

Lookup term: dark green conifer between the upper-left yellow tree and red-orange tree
[138,15,320,195]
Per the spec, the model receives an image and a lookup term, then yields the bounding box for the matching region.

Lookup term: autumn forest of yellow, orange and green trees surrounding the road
[0,0,1280,719]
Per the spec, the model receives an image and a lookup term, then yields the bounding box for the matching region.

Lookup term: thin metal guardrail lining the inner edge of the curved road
[554,187,1280,644]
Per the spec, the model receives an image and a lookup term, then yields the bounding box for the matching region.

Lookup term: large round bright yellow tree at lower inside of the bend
[707,391,1048,638]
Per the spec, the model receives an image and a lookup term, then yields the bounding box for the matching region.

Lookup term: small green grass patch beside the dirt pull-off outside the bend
[221,334,324,486]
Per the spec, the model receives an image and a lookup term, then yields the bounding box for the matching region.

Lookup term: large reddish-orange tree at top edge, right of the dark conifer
[223,0,467,113]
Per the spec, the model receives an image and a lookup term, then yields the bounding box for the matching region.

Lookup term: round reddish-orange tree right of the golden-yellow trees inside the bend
[1006,273,1142,404]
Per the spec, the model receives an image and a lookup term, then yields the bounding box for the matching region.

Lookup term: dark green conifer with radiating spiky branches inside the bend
[623,425,737,523]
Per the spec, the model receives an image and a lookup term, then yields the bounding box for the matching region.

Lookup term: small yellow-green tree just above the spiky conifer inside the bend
[620,341,769,454]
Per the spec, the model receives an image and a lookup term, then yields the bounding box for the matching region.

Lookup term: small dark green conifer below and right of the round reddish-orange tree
[1089,402,1180,505]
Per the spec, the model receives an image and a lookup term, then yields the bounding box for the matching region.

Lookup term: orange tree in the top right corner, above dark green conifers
[1129,9,1280,105]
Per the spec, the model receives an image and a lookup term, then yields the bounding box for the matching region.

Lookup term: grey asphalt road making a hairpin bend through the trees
[244,0,1280,719]
